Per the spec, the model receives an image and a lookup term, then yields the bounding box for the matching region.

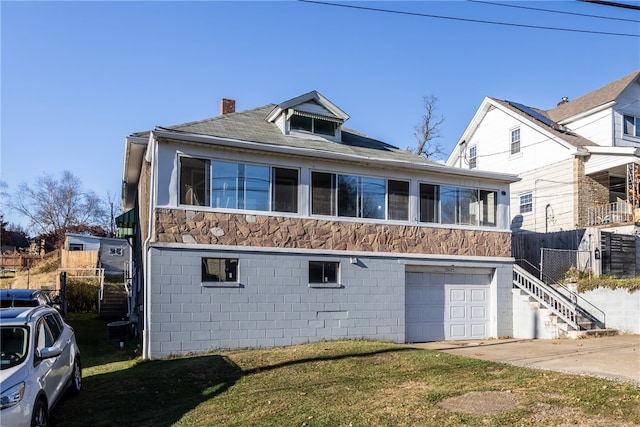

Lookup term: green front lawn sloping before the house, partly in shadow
[52,315,640,427]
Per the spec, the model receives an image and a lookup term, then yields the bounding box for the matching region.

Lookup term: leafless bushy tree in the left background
[10,171,109,246]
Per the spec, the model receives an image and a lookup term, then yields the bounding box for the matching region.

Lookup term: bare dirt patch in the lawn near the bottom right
[438,391,518,415]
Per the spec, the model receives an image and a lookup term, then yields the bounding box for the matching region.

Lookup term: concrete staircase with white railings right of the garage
[513,265,617,338]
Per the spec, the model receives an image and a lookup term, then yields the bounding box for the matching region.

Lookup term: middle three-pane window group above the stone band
[311,172,409,221]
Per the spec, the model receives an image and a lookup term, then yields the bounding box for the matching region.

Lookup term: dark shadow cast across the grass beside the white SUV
[51,348,412,427]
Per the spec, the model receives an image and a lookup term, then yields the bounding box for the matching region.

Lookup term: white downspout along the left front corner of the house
[142,132,157,360]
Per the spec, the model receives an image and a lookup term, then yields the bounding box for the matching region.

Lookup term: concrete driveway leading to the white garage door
[409,335,640,386]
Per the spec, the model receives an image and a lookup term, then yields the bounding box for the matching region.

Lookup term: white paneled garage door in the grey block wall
[405,270,491,342]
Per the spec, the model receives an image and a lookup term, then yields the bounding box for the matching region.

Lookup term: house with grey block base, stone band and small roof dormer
[118,91,517,358]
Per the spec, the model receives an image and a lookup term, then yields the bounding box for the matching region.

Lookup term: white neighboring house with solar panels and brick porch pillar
[446,70,640,233]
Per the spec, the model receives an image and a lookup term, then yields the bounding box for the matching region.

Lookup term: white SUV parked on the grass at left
[0,306,82,427]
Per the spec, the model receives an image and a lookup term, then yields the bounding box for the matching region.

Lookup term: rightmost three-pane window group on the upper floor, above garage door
[420,184,498,227]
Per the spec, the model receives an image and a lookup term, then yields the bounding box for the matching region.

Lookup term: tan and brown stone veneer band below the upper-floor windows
[154,209,511,257]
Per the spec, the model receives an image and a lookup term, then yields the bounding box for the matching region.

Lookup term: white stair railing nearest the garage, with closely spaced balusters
[513,264,580,330]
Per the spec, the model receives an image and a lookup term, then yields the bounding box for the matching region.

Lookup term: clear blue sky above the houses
[0,0,640,234]
